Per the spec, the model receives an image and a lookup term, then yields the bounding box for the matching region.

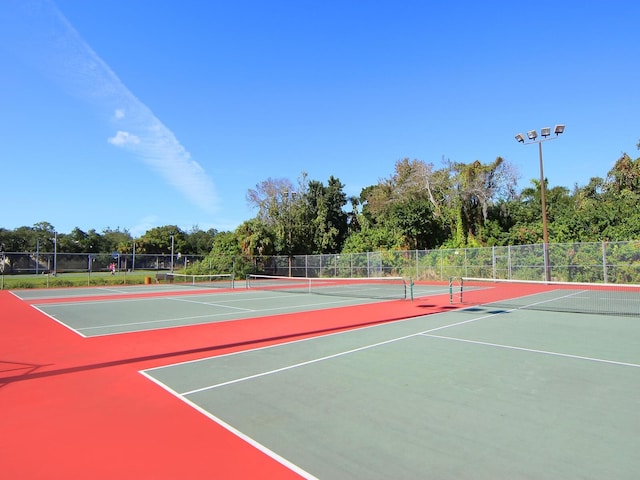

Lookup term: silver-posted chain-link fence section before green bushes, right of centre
[254,241,640,283]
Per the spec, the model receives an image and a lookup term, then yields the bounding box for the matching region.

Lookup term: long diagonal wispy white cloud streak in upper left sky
[0,0,217,212]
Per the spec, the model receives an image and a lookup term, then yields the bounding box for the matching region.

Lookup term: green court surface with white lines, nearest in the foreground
[144,305,640,479]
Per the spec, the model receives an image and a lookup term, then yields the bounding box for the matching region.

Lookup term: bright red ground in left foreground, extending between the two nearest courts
[0,284,544,480]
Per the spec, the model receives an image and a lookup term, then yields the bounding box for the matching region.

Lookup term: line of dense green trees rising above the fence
[0,139,640,266]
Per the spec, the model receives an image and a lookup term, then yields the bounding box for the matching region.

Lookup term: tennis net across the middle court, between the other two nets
[246,274,407,300]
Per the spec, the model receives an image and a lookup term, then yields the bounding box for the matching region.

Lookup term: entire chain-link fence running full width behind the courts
[0,240,640,284]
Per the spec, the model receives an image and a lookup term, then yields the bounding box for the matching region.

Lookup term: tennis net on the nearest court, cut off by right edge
[450,278,640,317]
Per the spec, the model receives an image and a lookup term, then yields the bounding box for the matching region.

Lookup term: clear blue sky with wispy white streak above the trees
[0,0,640,235]
